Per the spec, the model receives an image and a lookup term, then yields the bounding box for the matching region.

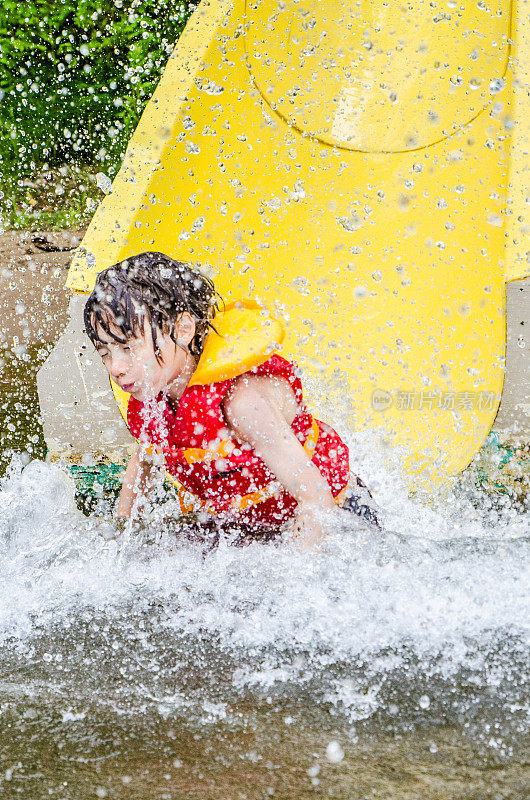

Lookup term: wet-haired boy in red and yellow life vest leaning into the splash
[85,253,379,546]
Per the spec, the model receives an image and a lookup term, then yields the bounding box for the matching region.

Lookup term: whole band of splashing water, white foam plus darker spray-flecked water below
[0,440,530,752]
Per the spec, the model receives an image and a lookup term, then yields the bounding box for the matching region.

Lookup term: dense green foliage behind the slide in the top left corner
[0,0,194,181]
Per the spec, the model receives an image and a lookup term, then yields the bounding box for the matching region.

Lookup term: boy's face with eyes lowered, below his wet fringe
[96,318,187,403]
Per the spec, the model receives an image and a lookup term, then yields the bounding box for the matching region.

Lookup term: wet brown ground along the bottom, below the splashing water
[1,696,530,800]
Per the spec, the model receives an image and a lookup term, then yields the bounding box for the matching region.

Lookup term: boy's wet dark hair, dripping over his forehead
[84,253,222,362]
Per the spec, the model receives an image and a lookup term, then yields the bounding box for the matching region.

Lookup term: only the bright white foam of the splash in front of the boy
[0,454,530,722]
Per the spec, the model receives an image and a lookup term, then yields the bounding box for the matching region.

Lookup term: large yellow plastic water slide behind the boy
[41,0,529,488]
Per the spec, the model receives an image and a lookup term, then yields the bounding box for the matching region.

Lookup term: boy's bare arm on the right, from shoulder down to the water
[223,375,335,539]
